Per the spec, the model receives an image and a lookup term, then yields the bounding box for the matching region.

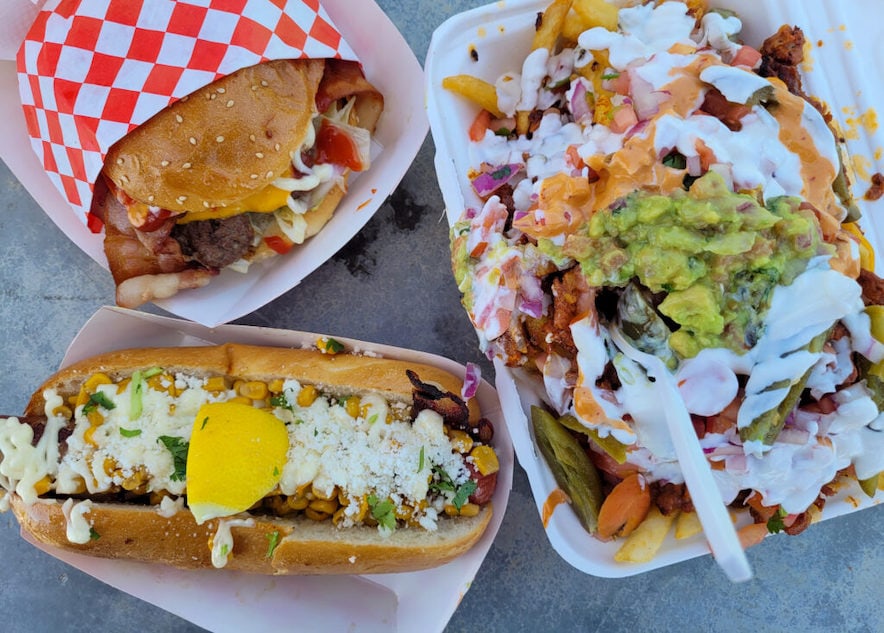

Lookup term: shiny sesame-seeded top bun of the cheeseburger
[104,59,324,211]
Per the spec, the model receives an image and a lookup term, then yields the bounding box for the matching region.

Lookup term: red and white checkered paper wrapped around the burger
[17,0,357,223]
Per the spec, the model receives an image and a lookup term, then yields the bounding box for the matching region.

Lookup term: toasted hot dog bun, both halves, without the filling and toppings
[0,344,493,574]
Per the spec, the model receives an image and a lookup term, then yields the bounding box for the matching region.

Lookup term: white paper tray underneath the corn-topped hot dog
[22,307,514,633]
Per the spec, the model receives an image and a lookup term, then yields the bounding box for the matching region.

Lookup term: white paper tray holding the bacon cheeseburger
[0,0,428,326]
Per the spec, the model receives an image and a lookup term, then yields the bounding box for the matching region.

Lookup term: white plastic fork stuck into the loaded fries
[610,327,752,582]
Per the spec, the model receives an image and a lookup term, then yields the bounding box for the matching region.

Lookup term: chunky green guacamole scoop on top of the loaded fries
[561,172,832,358]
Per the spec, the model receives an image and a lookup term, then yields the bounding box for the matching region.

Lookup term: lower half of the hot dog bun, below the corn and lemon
[10,494,492,575]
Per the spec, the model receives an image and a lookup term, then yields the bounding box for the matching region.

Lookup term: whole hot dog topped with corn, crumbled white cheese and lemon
[0,344,498,574]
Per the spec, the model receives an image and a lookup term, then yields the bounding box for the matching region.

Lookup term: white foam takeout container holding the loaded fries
[425,0,884,578]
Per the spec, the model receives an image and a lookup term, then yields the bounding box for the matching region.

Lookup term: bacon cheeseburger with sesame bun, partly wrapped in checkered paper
[92,59,384,307]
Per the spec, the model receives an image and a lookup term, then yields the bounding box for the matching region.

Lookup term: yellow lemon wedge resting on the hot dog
[187,402,289,523]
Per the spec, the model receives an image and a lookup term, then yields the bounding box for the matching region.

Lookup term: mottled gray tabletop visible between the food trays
[0,0,884,633]
